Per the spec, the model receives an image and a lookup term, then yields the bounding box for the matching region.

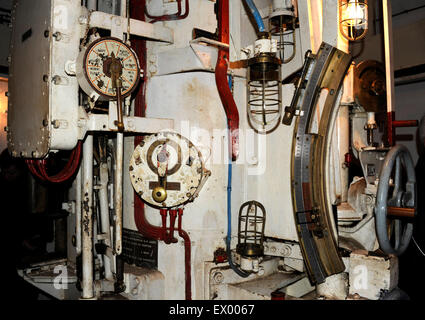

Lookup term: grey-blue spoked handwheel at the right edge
[375,145,416,256]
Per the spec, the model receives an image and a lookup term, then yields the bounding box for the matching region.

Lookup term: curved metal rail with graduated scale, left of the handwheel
[291,43,352,284]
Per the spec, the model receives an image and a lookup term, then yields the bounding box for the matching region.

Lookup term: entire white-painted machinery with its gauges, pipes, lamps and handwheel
[7,0,416,300]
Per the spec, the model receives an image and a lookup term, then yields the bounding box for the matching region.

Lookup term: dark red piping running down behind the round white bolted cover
[130,0,192,300]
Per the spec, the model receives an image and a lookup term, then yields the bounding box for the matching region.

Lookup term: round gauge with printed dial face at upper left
[77,37,140,100]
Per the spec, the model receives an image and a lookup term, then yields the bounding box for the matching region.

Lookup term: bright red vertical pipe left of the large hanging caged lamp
[215,0,239,161]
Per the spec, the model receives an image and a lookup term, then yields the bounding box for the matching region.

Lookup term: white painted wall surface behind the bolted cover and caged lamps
[124,0,304,299]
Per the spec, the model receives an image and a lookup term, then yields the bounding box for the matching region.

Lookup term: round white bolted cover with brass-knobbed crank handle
[130,132,211,208]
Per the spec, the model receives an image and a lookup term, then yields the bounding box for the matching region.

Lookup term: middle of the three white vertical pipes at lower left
[99,162,114,280]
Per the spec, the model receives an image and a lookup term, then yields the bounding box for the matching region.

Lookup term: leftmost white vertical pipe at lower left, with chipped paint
[81,135,94,299]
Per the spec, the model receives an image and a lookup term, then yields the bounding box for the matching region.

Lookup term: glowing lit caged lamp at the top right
[339,0,368,41]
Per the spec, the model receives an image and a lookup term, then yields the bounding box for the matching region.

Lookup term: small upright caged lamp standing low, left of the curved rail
[236,200,266,257]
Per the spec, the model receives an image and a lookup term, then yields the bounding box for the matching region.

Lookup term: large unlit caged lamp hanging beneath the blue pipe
[247,40,282,134]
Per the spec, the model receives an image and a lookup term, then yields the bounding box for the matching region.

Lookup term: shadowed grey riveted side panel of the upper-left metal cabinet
[8,0,52,157]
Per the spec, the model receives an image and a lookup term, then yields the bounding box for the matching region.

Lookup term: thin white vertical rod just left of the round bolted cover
[114,132,124,255]
